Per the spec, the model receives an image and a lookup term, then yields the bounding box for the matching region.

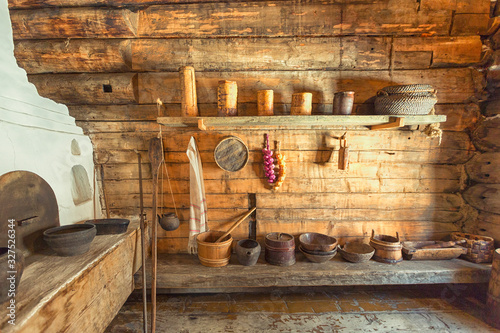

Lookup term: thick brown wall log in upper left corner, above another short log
[10,7,139,40]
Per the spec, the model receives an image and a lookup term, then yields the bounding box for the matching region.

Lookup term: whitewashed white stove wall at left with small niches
[0,0,100,225]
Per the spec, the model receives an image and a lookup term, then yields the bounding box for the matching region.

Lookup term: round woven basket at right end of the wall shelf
[375,84,437,115]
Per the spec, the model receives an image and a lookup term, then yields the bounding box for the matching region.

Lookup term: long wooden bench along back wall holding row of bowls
[135,253,491,293]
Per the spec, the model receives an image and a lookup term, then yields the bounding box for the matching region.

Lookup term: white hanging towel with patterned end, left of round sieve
[186,137,207,254]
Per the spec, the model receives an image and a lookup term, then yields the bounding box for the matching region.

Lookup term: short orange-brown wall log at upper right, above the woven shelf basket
[393,36,482,68]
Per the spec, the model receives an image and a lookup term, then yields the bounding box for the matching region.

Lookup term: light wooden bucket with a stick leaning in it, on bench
[196,231,233,267]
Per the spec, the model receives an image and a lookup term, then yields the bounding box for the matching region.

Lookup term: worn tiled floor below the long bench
[106,285,500,333]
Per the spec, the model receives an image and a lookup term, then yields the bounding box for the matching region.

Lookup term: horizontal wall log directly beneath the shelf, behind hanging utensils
[90,130,474,154]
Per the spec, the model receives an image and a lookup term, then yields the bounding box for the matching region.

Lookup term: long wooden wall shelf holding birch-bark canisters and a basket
[157,115,446,130]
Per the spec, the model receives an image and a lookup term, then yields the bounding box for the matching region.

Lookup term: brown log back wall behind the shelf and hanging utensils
[9,0,492,252]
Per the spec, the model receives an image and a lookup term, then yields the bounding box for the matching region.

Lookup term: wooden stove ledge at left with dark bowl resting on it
[0,222,141,333]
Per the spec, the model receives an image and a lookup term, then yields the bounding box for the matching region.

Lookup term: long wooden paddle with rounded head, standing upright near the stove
[149,138,163,333]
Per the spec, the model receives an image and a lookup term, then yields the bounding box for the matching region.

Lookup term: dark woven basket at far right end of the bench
[451,232,495,263]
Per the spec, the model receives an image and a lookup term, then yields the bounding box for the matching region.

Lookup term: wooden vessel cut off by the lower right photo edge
[485,249,500,329]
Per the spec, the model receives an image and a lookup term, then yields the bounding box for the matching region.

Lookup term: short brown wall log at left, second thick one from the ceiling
[14,39,132,74]
